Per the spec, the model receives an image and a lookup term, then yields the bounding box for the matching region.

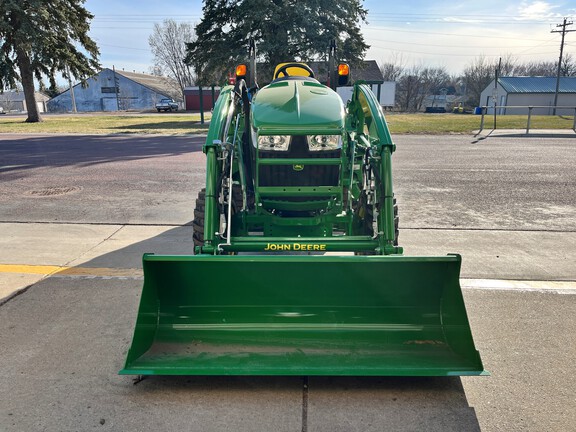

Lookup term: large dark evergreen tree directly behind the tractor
[186,0,369,84]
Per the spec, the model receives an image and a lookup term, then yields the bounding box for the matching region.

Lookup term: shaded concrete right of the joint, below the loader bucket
[308,377,480,432]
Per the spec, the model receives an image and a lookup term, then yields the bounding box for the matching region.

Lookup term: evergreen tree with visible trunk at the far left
[0,0,99,122]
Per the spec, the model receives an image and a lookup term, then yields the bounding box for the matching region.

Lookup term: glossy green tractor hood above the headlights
[252,79,345,135]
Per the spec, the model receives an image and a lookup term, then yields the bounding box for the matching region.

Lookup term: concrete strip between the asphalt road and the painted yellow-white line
[0,223,576,301]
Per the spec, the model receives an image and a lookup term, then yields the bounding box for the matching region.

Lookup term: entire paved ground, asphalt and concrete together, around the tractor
[0,135,576,432]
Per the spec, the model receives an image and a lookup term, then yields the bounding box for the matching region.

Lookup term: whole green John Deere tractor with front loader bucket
[120,45,485,376]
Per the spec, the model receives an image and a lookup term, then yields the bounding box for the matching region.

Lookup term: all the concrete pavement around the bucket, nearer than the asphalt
[0,223,576,432]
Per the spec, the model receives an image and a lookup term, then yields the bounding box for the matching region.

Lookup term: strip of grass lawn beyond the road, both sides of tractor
[0,113,574,135]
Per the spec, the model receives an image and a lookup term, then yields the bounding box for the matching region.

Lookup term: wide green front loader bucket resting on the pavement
[120,255,485,376]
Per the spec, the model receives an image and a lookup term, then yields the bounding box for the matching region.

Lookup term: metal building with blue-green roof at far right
[480,77,576,115]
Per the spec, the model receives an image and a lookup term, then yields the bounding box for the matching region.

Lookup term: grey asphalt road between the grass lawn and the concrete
[0,135,576,231]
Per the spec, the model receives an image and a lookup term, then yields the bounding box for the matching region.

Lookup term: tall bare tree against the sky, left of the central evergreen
[148,20,196,97]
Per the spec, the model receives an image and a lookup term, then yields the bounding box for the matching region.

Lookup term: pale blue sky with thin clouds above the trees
[84,0,576,75]
